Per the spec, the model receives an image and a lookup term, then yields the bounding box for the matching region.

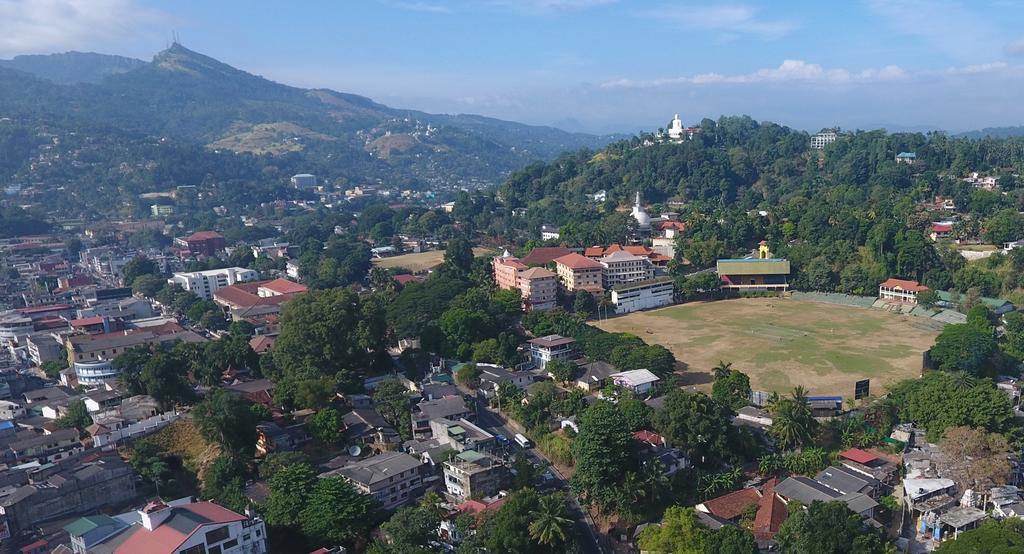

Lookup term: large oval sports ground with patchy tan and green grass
[595,298,938,398]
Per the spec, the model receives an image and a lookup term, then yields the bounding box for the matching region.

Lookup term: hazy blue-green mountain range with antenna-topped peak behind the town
[0,44,622,183]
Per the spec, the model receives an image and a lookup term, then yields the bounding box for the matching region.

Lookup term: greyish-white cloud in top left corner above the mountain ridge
[0,0,164,56]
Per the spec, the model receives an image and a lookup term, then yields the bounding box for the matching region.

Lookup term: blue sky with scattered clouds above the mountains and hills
[0,0,1024,132]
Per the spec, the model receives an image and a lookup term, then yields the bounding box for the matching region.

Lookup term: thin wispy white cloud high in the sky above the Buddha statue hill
[639,4,799,39]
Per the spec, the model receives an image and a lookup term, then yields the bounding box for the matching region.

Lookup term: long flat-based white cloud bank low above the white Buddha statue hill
[601,59,907,88]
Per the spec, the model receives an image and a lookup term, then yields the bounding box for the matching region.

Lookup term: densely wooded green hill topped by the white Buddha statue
[478,117,1024,294]
